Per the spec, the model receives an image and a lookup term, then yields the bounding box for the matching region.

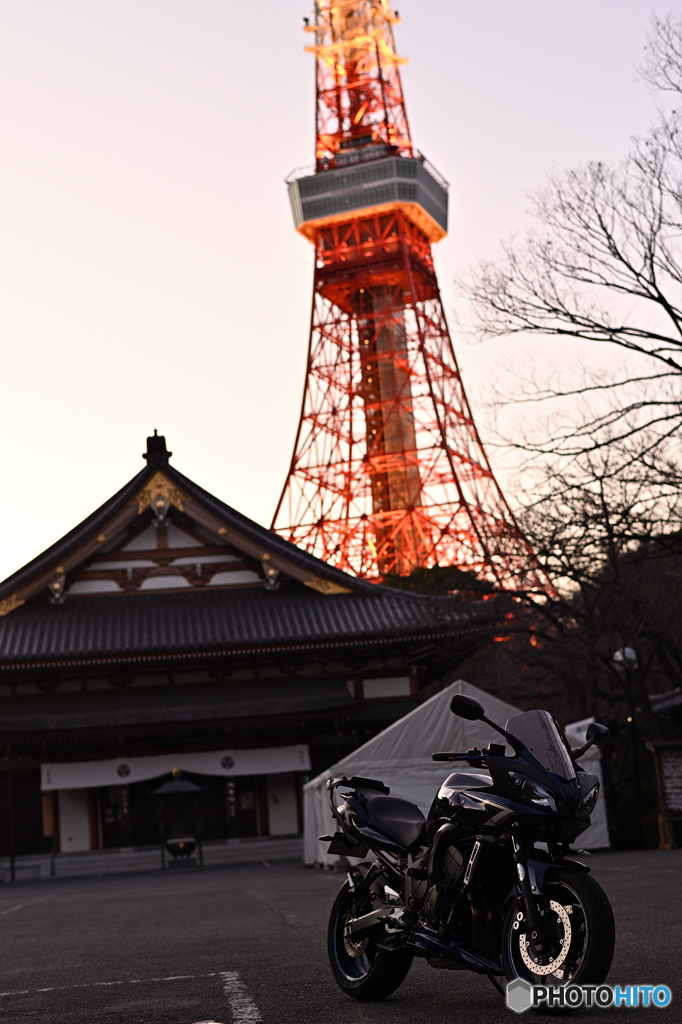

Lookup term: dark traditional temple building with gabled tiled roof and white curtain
[0,432,496,872]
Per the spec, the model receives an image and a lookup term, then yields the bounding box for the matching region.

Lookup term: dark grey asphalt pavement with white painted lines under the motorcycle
[0,850,682,1024]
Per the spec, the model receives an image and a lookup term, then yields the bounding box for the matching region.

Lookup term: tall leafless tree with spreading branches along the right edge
[458,15,682,716]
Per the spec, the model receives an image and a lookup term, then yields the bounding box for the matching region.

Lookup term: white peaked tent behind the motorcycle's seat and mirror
[303,679,520,864]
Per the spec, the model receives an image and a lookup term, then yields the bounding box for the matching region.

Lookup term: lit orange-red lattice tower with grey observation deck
[272,0,544,589]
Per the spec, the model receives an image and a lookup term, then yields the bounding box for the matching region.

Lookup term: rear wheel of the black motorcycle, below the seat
[327,882,412,1002]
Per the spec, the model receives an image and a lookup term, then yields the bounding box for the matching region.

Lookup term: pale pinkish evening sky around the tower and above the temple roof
[0,0,666,579]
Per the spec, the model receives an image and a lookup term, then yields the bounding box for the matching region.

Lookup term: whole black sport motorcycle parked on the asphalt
[321,695,615,999]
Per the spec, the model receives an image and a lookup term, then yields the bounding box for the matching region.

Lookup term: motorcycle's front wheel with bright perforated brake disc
[502,868,615,987]
